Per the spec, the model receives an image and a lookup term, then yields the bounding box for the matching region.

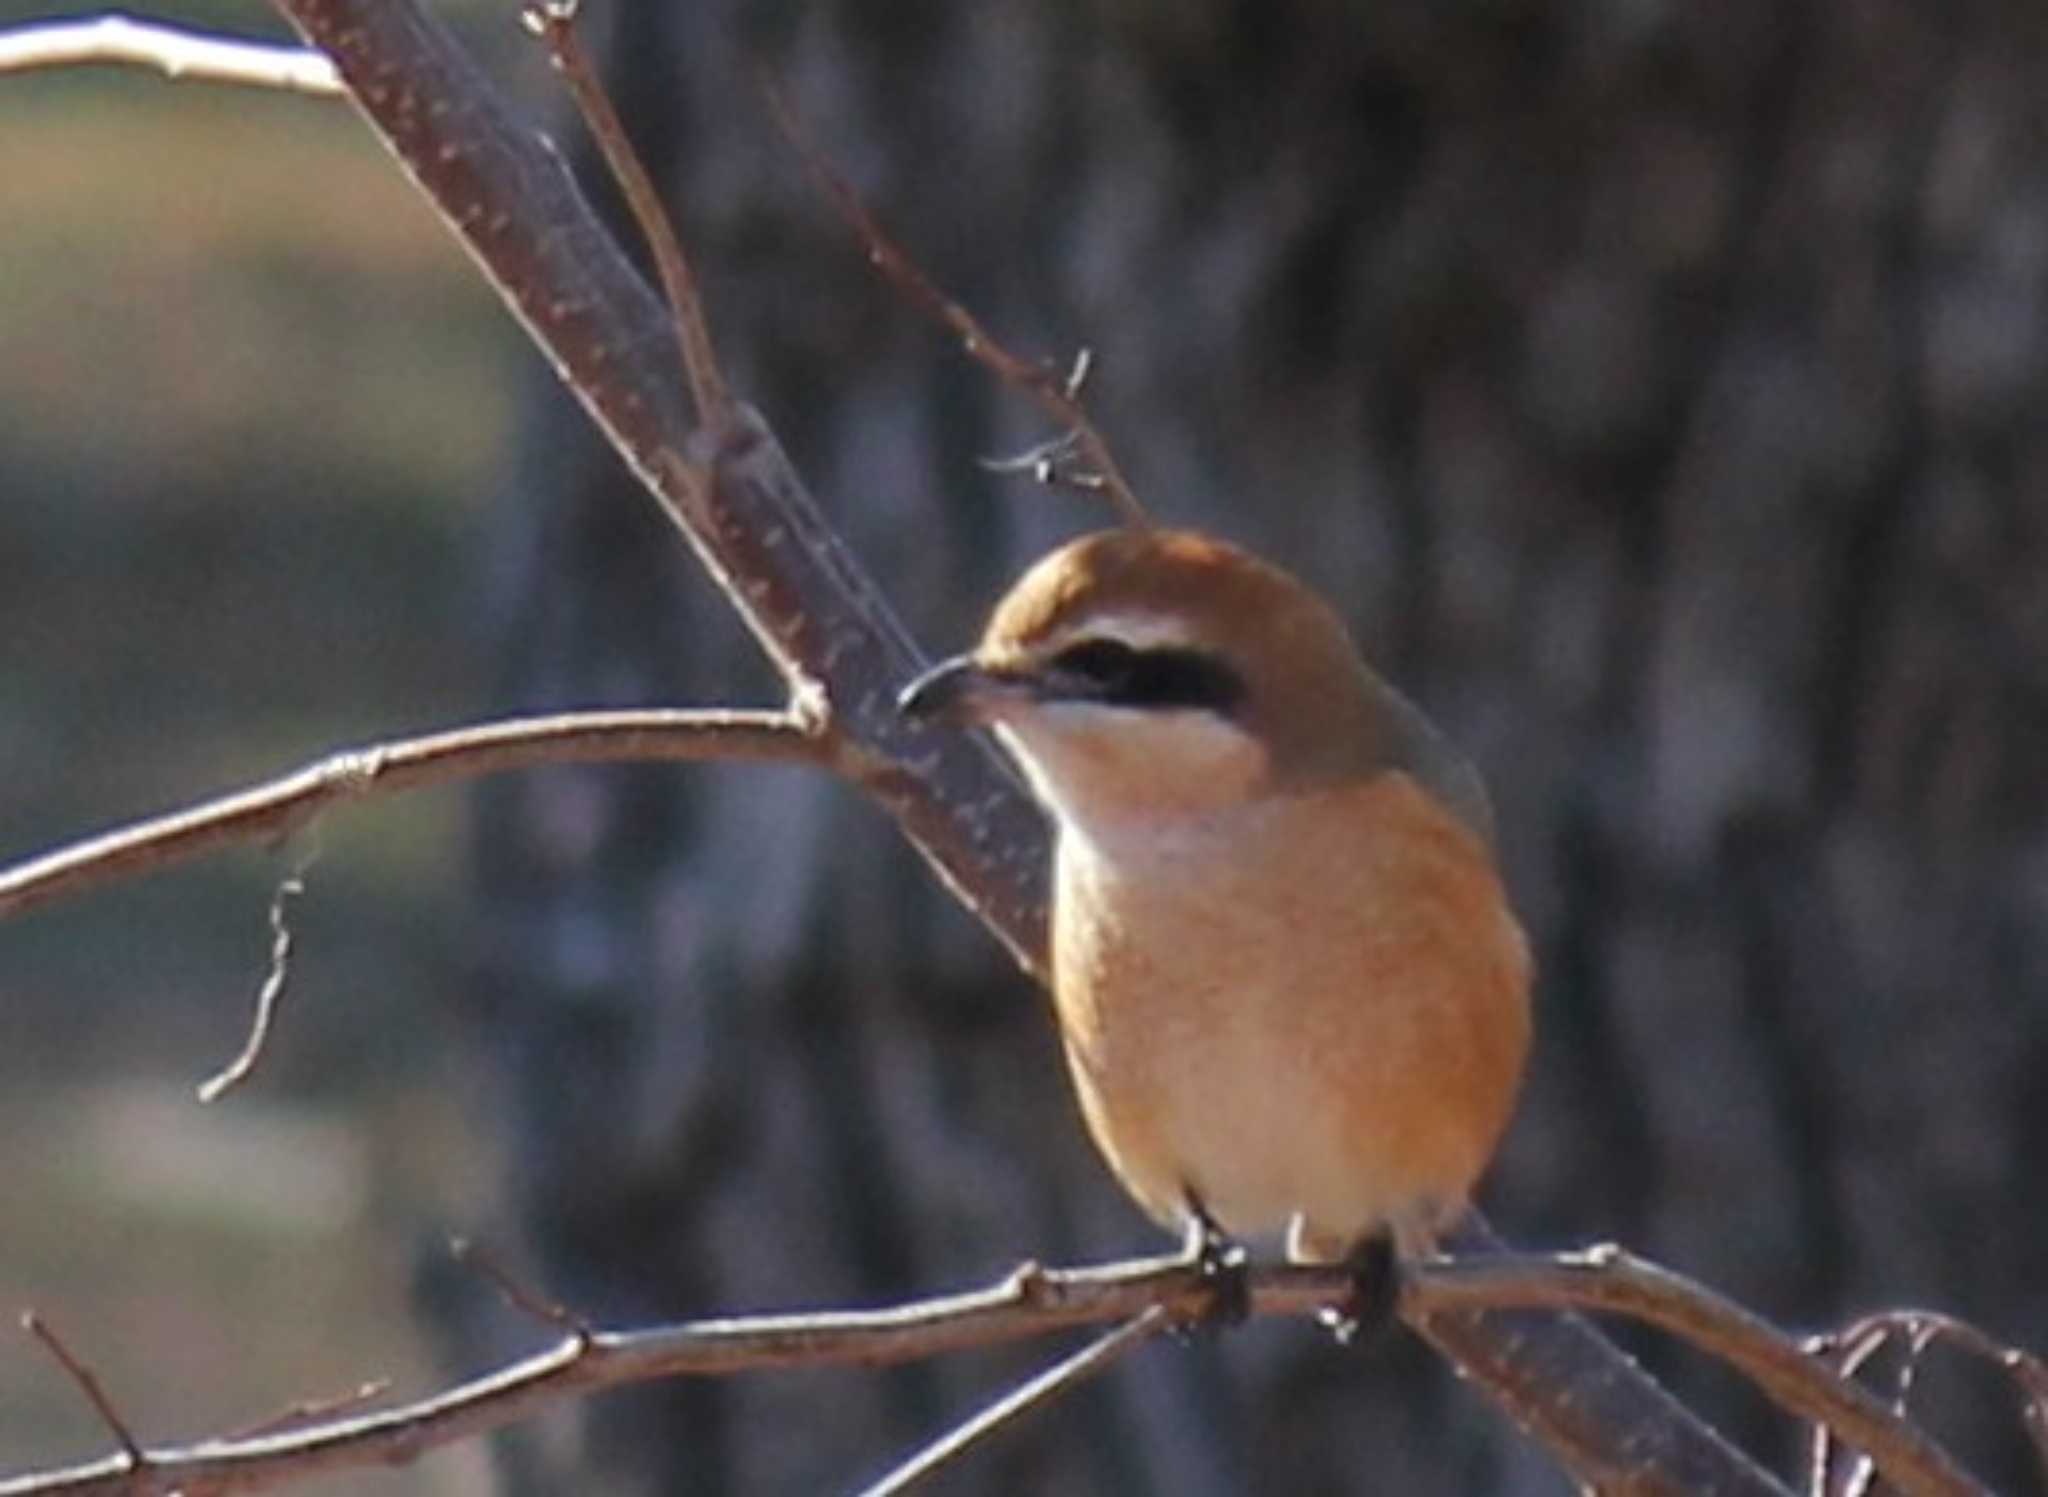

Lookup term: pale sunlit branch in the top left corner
[0,14,346,98]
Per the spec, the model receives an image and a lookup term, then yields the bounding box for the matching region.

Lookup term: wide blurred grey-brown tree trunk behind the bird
[444,0,2048,1493]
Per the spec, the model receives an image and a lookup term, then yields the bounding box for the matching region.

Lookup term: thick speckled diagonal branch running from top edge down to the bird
[272,0,1047,975]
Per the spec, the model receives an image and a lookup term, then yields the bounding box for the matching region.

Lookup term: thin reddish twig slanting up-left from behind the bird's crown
[762,78,1151,526]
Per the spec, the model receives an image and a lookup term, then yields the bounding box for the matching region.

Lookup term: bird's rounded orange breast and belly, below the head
[1053,772,1530,1257]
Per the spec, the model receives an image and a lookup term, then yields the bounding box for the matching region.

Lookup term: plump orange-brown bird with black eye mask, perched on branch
[897,524,1532,1310]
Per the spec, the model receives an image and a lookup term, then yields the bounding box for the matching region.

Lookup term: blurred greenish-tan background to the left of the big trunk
[0,0,530,1491]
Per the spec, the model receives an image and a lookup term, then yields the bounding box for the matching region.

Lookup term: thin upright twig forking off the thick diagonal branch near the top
[520,0,733,436]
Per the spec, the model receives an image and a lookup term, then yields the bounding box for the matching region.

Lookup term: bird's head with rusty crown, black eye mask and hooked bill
[901,528,1477,829]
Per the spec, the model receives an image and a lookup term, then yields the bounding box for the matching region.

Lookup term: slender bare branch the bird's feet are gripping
[0,1249,1985,1497]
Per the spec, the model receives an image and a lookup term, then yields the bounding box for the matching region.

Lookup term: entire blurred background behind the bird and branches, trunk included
[0,0,2048,1493]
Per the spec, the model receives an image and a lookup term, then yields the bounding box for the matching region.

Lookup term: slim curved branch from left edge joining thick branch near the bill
[0,709,838,917]
